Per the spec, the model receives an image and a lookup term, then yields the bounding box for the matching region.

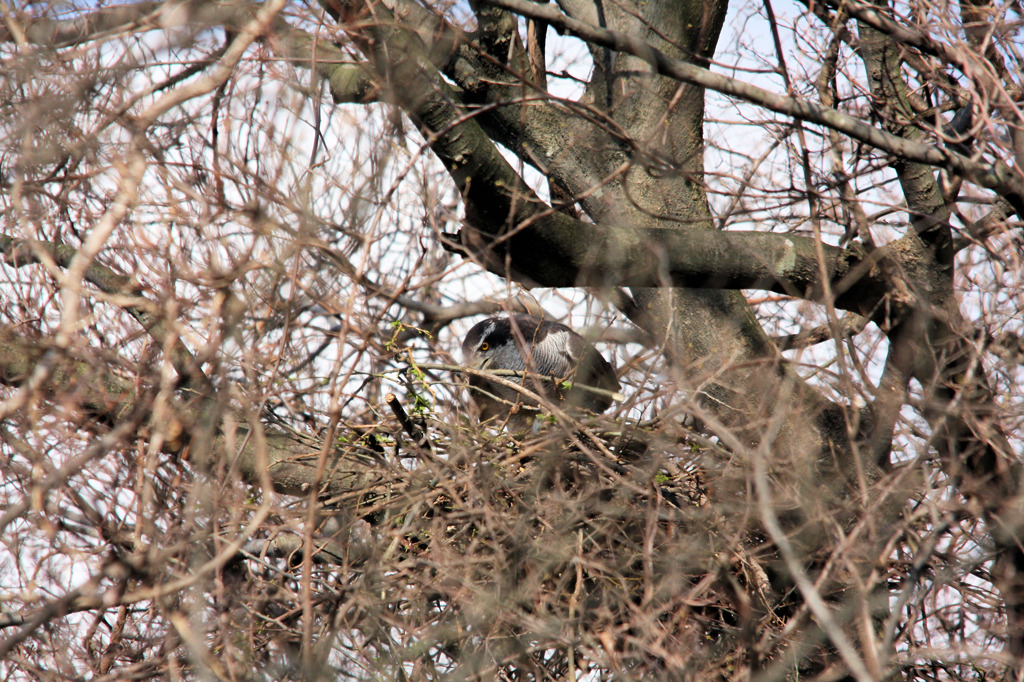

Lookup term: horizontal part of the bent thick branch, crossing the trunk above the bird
[457,218,898,316]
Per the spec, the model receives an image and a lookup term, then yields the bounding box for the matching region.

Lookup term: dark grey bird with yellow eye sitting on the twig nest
[462,314,622,430]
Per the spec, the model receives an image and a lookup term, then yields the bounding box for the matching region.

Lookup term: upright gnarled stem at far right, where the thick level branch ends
[859,11,1024,658]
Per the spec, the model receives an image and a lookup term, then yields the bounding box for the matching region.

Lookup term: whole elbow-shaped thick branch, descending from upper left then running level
[319,0,913,316]
